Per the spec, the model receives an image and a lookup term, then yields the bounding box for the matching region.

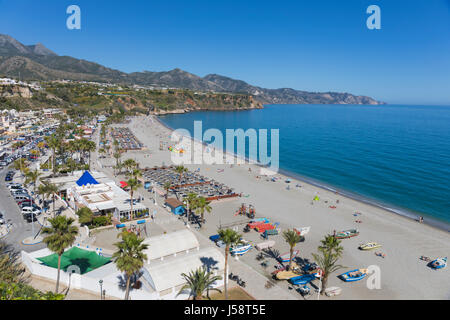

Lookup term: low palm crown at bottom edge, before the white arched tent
[177,266,222,300]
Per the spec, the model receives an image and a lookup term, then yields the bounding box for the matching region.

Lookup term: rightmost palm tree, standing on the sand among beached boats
[312,235,344,294]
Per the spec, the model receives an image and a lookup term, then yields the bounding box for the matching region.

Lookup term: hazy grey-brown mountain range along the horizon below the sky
[0,34,384,105]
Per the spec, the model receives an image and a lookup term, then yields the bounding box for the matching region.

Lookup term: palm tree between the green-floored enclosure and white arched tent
[112,231,148,300]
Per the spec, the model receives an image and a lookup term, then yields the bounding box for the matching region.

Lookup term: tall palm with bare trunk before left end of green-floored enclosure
[42,216,78,293]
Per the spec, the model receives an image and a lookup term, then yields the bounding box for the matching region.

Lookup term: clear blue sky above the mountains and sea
[0,0,450,105]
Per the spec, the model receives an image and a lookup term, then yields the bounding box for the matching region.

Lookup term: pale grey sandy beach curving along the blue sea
[107,116,450,299]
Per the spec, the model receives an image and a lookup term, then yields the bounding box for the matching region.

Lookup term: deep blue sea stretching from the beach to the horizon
[160,105,450,227]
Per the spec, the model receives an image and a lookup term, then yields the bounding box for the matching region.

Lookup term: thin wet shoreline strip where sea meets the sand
[156,115,450,232]
